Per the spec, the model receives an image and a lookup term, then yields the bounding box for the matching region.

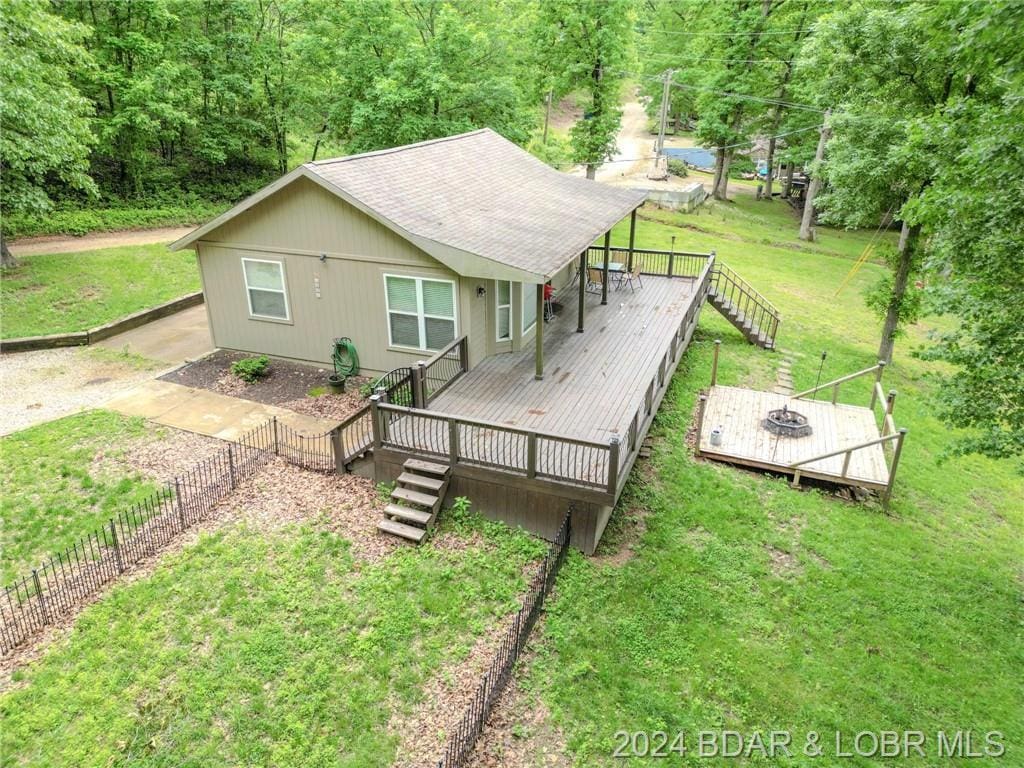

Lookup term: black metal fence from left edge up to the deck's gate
[0,419,335,654]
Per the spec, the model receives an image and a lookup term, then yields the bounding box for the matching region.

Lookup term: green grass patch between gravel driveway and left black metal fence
[0,411,157,584]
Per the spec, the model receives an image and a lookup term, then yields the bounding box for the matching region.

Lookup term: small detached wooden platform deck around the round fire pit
[699,386,889,489]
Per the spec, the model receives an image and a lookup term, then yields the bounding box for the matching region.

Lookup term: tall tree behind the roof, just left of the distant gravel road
[535,0,634,178]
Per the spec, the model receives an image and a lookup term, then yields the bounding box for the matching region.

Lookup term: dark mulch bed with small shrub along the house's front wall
[160,350,370,420]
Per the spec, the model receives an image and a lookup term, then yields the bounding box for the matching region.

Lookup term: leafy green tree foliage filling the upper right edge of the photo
[913,2,1024,469]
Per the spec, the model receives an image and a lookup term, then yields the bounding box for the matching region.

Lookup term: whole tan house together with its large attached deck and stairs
[172,129,777,552]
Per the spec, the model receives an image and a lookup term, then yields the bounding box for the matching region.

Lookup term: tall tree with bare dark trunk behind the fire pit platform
[803,2,970,361]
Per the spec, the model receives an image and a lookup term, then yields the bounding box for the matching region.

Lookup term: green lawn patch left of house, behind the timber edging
[0,240,200,339]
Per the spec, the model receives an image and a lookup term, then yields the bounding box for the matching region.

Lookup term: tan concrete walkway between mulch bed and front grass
[103,381,338,440]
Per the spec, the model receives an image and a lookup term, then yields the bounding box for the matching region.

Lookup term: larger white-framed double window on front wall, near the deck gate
[384,274,456,349]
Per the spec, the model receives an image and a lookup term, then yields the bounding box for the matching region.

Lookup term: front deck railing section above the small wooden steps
[371,403,621,494]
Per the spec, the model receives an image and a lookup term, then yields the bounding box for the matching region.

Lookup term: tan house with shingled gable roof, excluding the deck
[171,129,644,374]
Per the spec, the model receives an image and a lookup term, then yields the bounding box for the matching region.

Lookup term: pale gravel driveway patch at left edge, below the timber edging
[0,347,165,434]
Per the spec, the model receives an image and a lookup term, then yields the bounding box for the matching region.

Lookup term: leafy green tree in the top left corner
[0,0,95,267]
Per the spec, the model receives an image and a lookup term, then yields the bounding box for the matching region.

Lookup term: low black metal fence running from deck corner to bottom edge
[437,513,571,768]
